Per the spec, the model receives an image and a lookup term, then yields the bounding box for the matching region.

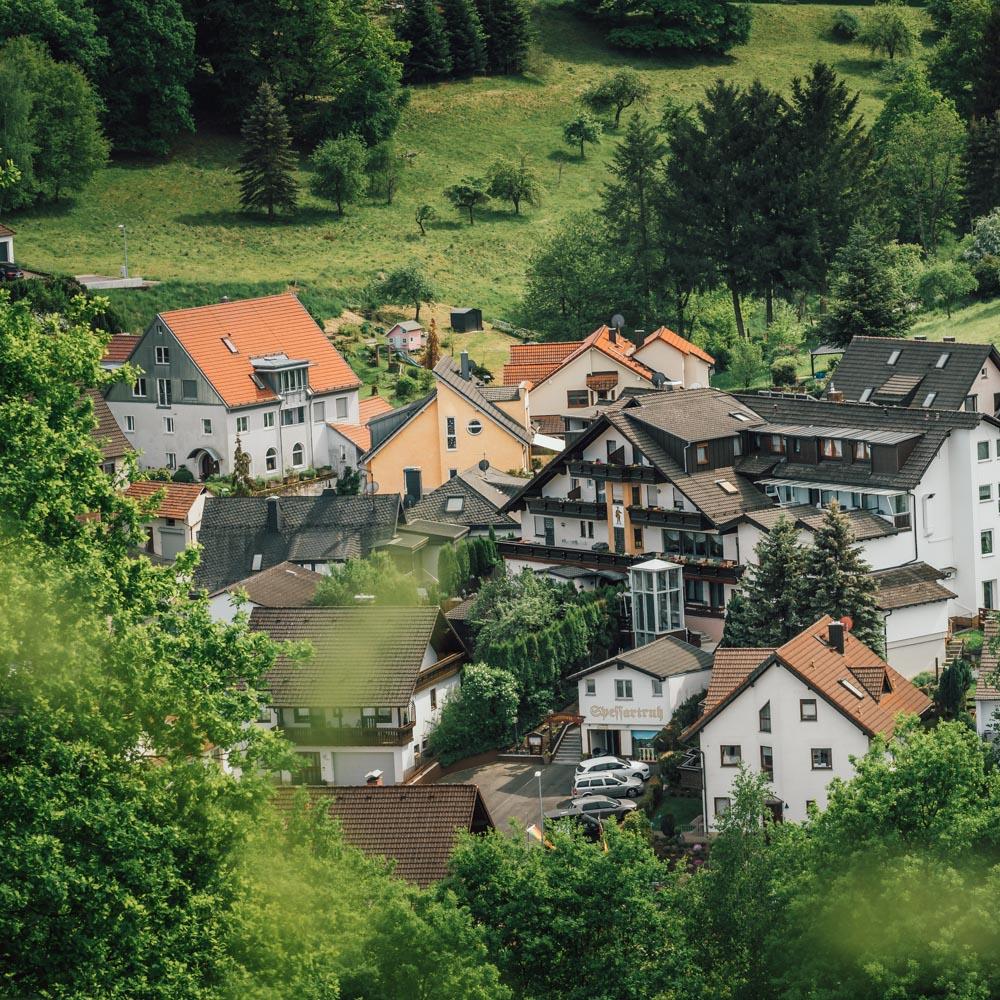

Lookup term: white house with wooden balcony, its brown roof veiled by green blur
[250,606,466,785]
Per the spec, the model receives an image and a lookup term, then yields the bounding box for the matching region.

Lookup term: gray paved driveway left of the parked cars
[444,761,576,833]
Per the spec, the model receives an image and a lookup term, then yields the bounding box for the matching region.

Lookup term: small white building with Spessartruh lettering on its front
[567,636,712,760]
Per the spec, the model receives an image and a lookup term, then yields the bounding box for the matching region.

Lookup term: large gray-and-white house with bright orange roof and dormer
[106,294,361,479]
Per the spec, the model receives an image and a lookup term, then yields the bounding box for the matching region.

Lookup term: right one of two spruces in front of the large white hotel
[802,501,885,655]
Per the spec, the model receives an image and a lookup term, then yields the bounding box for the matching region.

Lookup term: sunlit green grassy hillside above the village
[5,0,926,336]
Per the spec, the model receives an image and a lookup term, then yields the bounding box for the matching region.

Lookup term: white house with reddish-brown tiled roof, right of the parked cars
[684,616,931,829]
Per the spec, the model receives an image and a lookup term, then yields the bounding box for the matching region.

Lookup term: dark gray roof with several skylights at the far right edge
[832,337,1000,413]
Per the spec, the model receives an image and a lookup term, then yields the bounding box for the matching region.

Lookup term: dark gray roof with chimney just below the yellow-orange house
[195,493,400,593]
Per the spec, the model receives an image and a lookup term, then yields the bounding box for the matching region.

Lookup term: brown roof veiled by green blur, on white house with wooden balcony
[250,606,463,708]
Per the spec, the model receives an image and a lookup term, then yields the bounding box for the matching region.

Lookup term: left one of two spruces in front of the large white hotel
[722,516,809,647]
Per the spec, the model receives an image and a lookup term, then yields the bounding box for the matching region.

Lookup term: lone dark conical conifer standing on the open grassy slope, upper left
[240,83,298,219]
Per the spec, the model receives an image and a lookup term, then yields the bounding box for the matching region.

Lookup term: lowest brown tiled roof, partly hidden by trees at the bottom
[276,784,494,887]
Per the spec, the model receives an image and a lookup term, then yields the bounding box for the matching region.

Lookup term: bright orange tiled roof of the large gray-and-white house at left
[160,293,361,406]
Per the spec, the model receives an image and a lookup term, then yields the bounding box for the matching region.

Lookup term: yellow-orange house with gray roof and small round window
[361,352,532,502]
